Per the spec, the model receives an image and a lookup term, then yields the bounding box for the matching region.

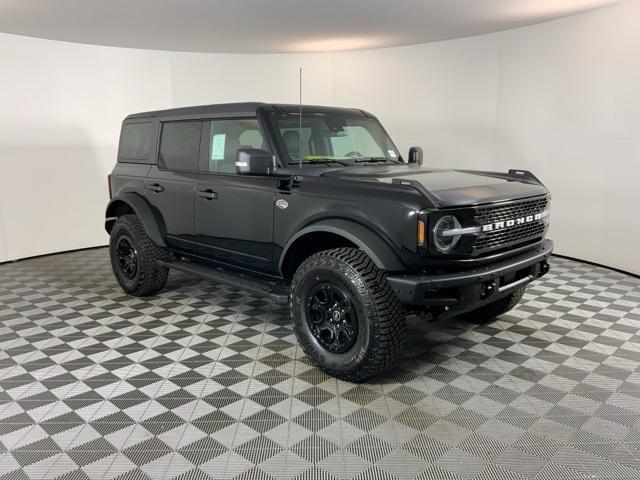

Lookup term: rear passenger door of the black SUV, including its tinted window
[145,120,202,250]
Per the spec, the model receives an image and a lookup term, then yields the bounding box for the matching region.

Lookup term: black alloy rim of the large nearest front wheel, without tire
[305,283,358,353]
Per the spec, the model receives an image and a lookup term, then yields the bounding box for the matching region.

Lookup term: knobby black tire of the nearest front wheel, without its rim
[289,248,406,382]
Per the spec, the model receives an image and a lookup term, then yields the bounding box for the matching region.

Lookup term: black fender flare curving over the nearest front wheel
[278,219,406,272]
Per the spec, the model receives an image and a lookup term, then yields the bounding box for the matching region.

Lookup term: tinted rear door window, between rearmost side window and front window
[158,121,202,171]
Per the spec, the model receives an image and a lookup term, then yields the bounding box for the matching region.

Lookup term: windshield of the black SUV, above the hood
[272,113,400,165]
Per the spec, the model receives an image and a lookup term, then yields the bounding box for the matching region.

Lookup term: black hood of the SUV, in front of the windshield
[323,165,548,207]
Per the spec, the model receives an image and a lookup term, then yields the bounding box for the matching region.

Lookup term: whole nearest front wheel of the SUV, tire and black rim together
[291,248,406,381]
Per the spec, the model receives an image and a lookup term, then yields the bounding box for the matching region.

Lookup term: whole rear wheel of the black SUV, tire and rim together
[109,215,169,296]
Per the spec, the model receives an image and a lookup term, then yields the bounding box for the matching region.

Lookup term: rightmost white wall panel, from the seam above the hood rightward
[495,0,640,273]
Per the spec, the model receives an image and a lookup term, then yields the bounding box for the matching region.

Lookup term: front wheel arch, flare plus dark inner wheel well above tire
[278,219,405,278]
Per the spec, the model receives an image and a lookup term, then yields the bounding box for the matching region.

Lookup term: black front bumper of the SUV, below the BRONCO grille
[387,240,553,313]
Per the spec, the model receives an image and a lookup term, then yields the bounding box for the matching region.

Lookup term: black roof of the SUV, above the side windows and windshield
[126,102,372,120]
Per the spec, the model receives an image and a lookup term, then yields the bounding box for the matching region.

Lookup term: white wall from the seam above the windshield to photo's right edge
[333,0,640,273]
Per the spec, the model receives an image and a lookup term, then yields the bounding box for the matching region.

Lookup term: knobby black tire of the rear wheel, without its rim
[109,215,169,297]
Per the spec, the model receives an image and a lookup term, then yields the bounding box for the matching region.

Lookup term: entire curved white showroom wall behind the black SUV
[0,0,640,273]
